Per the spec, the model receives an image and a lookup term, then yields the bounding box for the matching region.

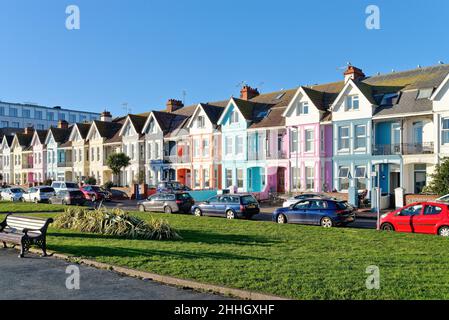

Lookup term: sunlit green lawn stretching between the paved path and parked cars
[30,213,449,299]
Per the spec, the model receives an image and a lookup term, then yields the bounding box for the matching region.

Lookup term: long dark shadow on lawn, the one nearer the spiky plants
[49,230,279,246]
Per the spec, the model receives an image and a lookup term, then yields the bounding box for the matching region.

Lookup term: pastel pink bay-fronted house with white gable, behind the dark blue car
[283,82,344,192]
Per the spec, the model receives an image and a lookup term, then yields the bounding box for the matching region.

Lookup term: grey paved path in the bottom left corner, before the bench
[0,249,224,300]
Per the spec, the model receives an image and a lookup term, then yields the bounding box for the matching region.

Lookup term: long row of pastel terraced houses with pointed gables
[0,65,449,200]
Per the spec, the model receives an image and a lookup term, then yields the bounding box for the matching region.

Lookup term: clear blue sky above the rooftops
[0,0,449,115]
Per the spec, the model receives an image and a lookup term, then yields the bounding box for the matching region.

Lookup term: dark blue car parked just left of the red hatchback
[272,199,355,228]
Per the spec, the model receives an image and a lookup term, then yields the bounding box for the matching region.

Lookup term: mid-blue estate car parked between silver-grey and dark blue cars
[192,194,260,219]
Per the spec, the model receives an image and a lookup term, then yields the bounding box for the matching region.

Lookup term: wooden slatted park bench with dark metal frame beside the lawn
[0,214,53,258]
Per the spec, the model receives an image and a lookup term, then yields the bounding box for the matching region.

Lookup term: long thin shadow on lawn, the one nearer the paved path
[49,245,268,260]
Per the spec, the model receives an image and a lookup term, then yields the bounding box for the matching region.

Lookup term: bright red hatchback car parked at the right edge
[380,202,449,237]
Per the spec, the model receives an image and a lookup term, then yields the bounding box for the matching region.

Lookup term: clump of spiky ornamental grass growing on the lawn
[54,208,181,240]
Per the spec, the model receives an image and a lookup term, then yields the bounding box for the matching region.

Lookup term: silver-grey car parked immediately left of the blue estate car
[137,192,195,213]
